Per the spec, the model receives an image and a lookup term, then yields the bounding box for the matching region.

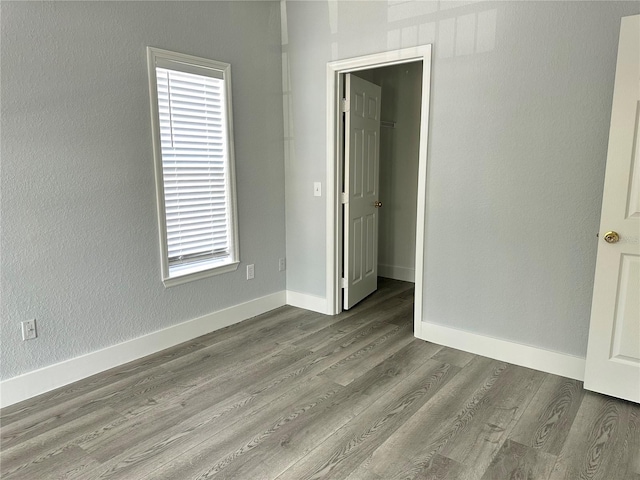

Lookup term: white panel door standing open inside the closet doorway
[343,74,381,310]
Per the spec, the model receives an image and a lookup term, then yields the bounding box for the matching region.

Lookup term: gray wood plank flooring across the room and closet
[0,279,640,480]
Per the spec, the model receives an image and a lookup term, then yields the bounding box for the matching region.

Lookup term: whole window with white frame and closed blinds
[147,47,240,286]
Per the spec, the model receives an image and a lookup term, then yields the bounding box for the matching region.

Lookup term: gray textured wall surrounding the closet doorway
[283,1,640,356]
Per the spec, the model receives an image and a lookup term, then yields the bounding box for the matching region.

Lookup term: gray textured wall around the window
[0,1,285,379]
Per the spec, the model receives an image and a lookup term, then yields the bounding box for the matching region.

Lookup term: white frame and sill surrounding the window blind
[147,47,240,287]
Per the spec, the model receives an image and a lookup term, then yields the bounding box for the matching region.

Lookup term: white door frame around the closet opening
[326,45,432,336]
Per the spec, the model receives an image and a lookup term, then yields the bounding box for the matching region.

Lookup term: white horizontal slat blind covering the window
[156,67,230,267]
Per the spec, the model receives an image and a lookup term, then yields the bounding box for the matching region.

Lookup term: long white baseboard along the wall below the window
[0,291,286,407]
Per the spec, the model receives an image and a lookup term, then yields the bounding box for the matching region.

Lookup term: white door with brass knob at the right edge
[584,15,640,402]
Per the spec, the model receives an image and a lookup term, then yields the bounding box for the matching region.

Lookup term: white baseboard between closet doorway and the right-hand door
[415,322,585,381]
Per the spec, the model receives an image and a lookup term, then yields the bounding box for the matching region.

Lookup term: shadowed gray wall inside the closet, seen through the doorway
[355,62,422,279]
